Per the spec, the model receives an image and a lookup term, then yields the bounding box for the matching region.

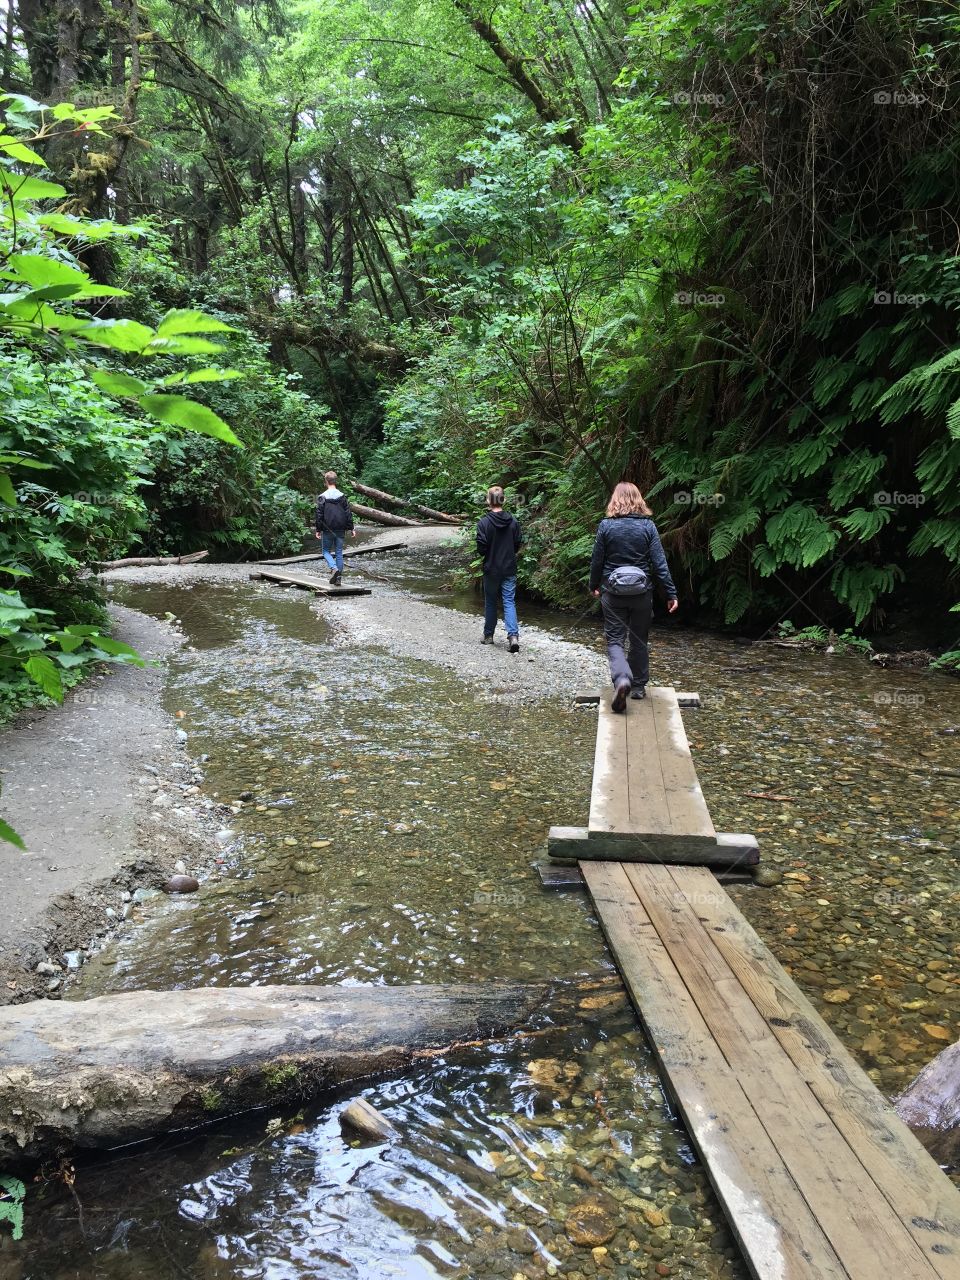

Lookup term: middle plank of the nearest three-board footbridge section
[626,865,936,1280]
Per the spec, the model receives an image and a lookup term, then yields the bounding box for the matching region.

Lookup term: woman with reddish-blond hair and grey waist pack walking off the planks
[590,483,677,712]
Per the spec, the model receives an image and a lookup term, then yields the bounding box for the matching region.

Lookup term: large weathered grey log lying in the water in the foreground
[0,983,549,1166]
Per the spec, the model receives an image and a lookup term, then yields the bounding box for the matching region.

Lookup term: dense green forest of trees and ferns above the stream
[0,0,960,721]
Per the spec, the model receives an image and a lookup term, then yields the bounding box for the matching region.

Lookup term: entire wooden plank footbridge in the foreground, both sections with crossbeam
[550,689,960,1280]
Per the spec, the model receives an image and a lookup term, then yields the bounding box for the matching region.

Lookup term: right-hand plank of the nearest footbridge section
[669,868,960,1280]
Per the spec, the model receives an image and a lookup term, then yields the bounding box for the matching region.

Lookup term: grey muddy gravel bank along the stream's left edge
[0,607,224,1005]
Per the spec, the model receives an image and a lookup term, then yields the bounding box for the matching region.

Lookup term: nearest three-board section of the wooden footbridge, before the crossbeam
[581,863,960,1280]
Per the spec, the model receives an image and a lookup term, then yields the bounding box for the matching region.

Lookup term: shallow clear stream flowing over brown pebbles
[9,540,960,1280]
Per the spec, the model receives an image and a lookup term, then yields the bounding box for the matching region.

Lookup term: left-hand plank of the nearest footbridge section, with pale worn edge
[581,863,849,1280]
